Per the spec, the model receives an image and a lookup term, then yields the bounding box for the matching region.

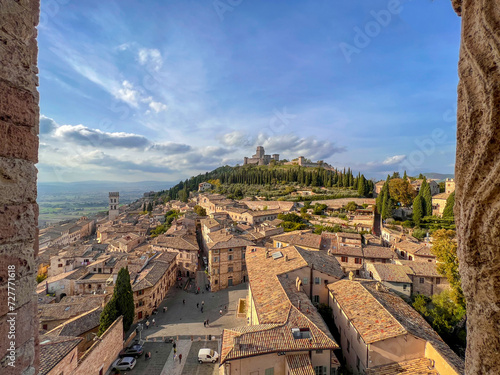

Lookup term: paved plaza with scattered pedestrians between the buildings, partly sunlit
[111,284,247,375]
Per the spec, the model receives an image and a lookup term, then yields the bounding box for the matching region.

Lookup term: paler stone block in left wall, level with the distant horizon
[0,157,37,205]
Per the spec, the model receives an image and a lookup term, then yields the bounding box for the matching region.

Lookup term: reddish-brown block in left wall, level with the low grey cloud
[0,122,38,163]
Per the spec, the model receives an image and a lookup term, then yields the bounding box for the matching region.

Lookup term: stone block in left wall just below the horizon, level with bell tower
[0,204,38,244]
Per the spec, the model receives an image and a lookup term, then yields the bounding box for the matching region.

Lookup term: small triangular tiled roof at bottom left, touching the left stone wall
[38,335,83,375]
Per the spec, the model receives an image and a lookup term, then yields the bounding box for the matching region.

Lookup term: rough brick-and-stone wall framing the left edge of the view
[0,0,40,375]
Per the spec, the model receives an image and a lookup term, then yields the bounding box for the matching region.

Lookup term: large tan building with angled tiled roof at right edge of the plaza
[219,246,343,375]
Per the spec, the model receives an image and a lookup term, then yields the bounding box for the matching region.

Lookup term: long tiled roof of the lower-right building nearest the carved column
[328,280,464,373]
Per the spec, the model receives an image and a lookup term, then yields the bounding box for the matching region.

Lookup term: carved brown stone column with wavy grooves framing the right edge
[452,0,500,374]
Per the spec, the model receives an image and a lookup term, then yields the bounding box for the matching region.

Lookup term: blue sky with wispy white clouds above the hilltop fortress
[38,0,460,182]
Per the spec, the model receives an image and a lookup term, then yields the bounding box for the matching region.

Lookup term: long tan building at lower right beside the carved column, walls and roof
[328,280,464,375]
